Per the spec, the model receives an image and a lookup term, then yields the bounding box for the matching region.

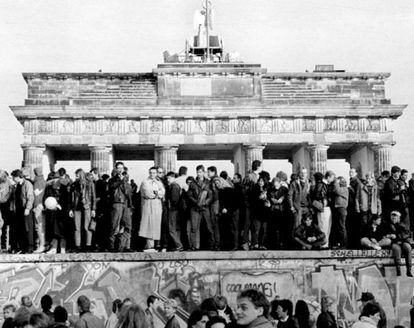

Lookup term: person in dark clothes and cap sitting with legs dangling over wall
[386,211,413,277]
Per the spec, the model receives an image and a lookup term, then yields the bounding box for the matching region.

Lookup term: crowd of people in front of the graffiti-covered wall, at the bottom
[2,289,414,328]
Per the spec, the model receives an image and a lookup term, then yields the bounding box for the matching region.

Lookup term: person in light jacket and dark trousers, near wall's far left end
[11,170,34,253]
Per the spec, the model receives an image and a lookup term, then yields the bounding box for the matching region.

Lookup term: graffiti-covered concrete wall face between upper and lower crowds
[0,259,414,327]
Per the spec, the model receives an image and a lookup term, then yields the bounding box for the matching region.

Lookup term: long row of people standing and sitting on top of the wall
[0,160,414,276]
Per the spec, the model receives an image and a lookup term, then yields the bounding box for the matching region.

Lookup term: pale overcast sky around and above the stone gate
[0,0,414,182]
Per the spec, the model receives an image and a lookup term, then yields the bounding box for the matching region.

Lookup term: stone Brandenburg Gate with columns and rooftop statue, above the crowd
[11,3,405,174]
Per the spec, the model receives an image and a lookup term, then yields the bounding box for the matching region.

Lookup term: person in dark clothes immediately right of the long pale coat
[165,172,184,252]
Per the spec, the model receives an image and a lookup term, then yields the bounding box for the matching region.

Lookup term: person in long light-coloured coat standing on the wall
[139,167,165,252]
